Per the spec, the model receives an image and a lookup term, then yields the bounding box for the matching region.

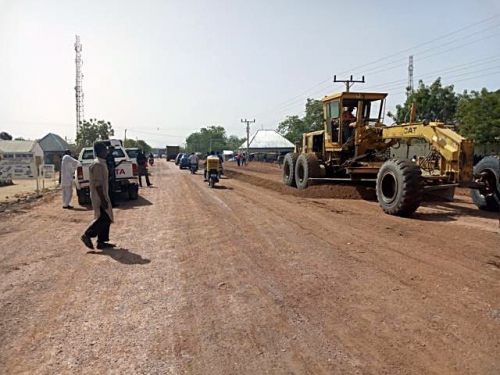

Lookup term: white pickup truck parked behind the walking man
[75,146,139,206]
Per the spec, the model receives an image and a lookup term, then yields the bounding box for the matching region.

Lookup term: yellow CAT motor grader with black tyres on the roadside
[283,92,500,216]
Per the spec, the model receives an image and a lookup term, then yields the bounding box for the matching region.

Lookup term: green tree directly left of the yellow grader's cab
[278,99,324,142]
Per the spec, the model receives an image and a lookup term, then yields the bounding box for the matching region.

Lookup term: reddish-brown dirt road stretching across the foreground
[0,160,500,374]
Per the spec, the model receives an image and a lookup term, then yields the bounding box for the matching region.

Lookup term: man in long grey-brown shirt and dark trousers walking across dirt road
[81,142,115,250]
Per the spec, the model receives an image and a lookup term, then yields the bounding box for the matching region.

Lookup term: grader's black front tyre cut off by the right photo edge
[470,156,500,211]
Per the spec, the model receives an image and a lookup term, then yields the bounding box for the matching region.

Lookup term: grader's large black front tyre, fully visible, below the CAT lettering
[376,159,424,216]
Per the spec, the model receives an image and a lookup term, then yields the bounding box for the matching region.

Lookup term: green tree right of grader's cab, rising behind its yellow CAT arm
[387,78,459,124]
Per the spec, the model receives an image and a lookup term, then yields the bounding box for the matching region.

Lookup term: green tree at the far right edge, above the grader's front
[456,89,500,143]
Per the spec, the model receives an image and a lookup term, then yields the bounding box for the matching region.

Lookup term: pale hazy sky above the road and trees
[0,0,500,147]
